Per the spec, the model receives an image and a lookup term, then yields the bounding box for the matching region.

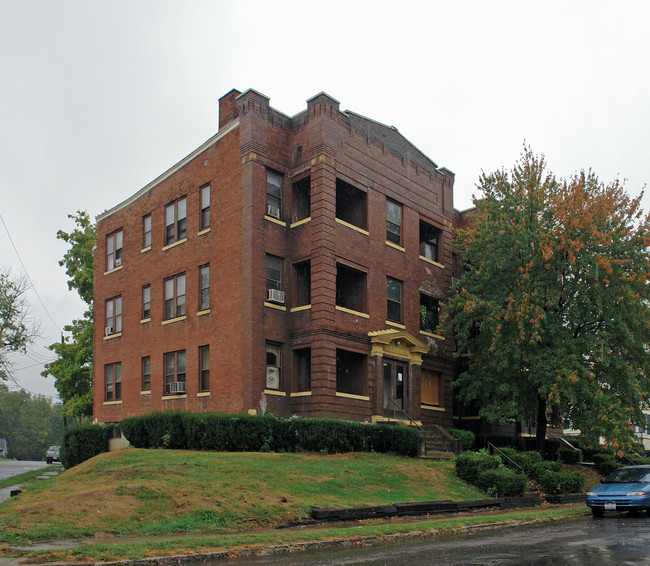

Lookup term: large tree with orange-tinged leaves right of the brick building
[447,148,650,450]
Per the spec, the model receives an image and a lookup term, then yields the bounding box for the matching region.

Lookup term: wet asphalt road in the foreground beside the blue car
[227,514,650,566]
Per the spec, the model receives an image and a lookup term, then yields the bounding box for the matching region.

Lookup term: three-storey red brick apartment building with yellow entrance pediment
[93,90,455,427]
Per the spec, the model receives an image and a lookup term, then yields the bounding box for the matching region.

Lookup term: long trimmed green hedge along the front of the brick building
[120,412,419,456]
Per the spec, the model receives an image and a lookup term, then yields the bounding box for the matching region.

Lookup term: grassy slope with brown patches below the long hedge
[0,449,483,544]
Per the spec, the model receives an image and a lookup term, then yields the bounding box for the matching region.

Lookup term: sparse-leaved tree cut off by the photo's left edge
[0,272,37,380]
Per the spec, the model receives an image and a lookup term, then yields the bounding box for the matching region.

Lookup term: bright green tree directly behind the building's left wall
[42,211,96,417]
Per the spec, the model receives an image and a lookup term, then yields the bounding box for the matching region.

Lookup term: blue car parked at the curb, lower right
[585,466,650,517]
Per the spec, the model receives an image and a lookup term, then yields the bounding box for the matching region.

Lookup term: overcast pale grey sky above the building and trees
[0,0,650,395]
